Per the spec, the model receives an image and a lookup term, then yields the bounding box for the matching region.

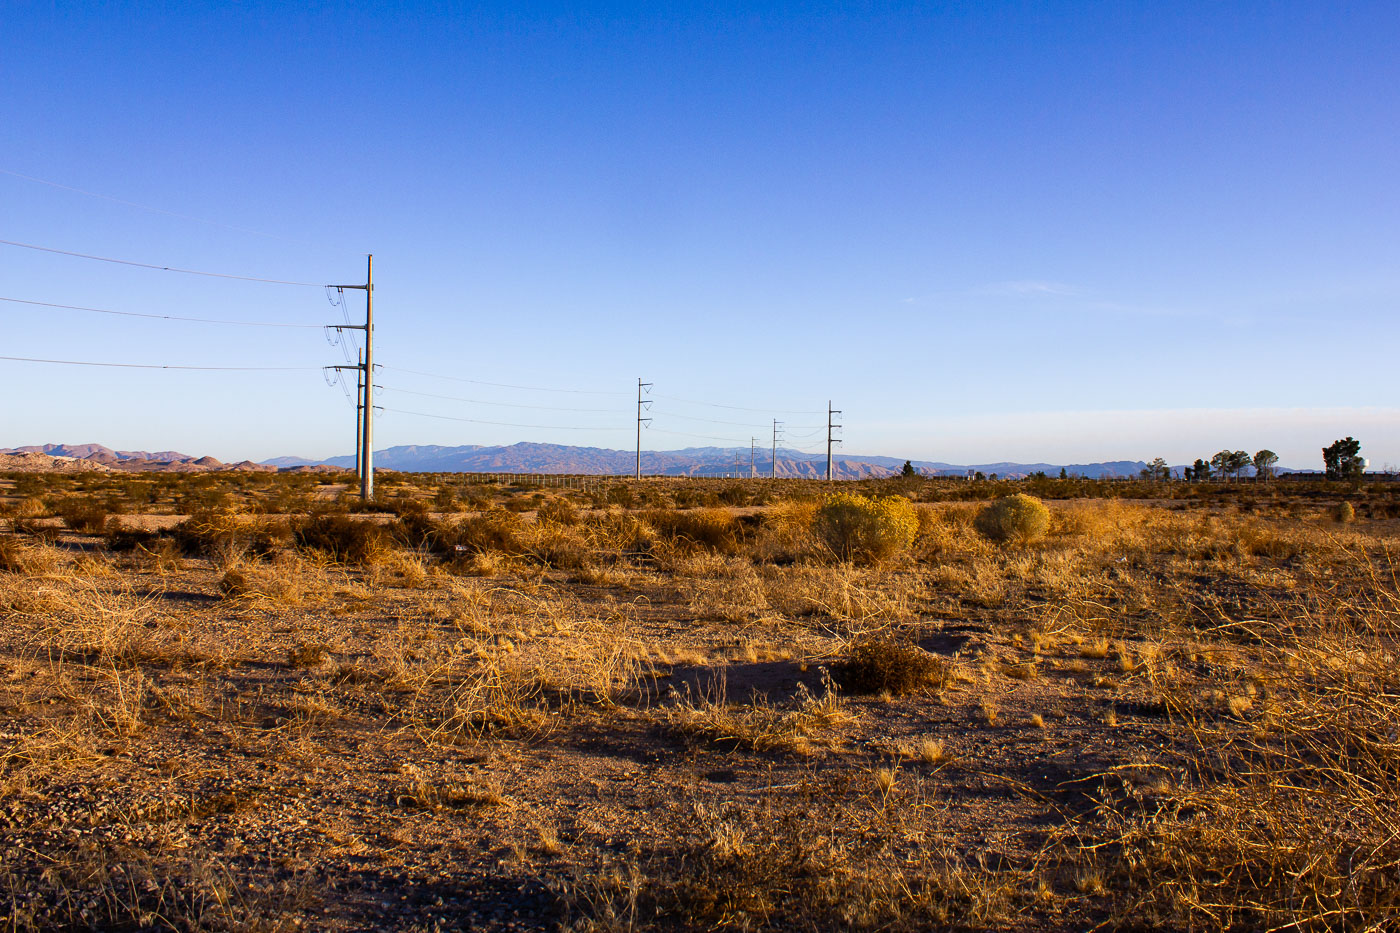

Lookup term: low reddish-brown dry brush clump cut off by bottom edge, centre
[561,790,1022,930]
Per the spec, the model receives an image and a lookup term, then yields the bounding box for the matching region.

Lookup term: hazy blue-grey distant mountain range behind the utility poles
[263,443,1147,479]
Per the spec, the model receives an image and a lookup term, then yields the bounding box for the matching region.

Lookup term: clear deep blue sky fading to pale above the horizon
[0,0,1400,467]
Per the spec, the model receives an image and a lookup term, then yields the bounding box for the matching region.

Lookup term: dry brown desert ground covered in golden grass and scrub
[0,474,1400,932]
